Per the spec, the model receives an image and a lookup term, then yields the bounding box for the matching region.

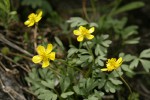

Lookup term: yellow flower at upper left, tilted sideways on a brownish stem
[24,11,43,27]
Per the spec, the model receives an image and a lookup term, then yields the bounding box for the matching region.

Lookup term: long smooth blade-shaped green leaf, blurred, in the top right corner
[113,1,145,15]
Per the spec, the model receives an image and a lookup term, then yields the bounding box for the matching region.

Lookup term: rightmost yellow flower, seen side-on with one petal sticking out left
[101,57,123,71]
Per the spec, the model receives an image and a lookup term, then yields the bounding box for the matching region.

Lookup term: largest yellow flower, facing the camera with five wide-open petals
[32,44,55,68]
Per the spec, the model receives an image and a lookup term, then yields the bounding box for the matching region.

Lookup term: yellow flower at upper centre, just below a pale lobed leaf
[73,26,95,42]
